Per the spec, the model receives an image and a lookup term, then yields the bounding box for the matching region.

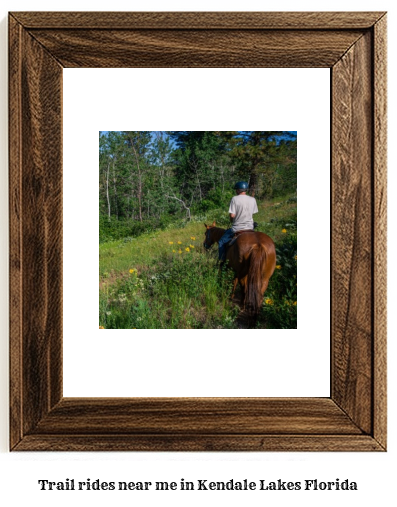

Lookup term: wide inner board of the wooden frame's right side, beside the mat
[332,33,373,433]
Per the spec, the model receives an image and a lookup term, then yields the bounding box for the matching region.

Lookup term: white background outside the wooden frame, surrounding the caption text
[0,0,397,506]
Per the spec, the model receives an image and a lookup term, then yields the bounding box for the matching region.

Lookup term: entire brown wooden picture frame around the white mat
[9,12,386,451]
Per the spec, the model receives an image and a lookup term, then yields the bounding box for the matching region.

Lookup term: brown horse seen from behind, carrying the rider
[204,222,276,317]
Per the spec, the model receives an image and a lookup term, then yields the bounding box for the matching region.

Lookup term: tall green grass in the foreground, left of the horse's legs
[100,247,238,329]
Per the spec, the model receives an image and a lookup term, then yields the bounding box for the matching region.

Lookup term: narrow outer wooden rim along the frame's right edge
[373,17,387,447]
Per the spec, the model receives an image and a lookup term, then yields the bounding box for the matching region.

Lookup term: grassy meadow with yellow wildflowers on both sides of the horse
[99,194,296,329]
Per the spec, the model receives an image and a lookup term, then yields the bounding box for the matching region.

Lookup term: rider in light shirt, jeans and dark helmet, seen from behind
[218,181,258,263]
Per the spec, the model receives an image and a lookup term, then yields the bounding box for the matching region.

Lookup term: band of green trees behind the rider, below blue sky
[99,131,296,242]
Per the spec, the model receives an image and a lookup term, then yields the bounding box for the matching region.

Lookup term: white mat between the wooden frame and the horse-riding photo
[63,69,330,397]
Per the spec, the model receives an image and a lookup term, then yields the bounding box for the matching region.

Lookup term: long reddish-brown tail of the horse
[245,243,267,316]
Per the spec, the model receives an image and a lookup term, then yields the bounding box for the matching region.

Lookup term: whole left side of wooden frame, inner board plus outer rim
[10,15,62,441]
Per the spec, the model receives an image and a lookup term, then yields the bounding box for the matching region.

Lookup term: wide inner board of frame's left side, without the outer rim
[21,31,62,431]
